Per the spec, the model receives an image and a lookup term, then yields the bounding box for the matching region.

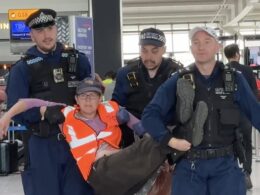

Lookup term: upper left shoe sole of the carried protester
[176,78,195,124]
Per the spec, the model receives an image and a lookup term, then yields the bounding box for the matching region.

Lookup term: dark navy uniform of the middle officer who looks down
[112,58,179,147]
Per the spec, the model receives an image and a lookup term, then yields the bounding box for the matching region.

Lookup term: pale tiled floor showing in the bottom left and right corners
[0,160,260,195]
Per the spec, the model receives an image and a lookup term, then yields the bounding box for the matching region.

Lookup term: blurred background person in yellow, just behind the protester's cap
[103,70,116,100]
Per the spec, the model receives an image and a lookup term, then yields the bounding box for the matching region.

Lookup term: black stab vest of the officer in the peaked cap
[23,50,79,105]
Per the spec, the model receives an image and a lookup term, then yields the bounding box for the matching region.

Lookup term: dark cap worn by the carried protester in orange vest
[76,78,104,95]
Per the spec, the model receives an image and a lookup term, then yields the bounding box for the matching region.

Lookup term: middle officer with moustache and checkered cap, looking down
[112,28,182,146]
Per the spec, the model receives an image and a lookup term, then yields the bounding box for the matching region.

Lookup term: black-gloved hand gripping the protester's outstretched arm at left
[44,106,65,125]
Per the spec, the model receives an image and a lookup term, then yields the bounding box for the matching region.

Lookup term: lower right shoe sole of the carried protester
[188,101,208,146]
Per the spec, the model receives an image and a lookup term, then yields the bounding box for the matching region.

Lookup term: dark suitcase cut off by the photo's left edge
[0,142,10,175]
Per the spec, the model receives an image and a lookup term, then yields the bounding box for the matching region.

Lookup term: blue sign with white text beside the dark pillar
[75,16,95,75]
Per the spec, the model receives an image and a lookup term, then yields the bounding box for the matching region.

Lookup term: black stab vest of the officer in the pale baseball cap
[191,64,240,148]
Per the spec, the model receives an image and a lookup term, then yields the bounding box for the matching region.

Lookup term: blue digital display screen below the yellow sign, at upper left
[10,21,31,41]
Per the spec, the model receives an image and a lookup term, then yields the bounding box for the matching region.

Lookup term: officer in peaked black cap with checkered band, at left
[7,9,91,195]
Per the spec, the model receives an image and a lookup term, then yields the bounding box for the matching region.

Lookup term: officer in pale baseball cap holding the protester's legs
[142,27,260,195]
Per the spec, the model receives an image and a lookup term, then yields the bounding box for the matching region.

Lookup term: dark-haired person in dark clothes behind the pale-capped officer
[224,44,257,189]
